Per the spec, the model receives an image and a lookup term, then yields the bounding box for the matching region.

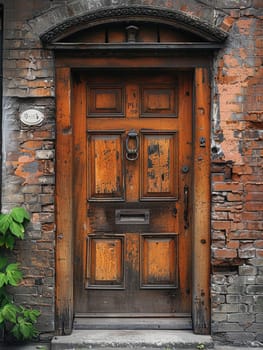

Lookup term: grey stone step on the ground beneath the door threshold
[51,330,214,350]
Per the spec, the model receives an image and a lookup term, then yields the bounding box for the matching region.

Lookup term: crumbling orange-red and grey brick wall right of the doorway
[211,1,263,345]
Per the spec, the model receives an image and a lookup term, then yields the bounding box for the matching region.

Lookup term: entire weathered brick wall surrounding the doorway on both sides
[0,0,263,343]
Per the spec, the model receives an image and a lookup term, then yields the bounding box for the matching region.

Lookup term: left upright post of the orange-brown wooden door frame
[56,68,73,334]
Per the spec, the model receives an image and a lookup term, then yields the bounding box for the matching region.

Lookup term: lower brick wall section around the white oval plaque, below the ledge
[2,97,55,337]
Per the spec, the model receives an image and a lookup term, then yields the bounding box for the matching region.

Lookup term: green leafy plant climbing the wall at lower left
[0,207,40,341]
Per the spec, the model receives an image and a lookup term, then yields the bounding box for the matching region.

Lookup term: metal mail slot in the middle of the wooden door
[115,209,150,225]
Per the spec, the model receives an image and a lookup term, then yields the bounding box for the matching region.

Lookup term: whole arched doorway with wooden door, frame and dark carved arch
[42,7,227,334]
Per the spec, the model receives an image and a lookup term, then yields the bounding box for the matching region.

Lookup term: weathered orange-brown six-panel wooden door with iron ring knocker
[73,70,192,328]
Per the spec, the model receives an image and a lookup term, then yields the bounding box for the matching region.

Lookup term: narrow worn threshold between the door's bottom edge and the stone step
[73,316,192,330]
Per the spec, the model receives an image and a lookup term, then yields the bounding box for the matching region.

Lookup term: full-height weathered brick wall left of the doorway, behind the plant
[2,0,55,338]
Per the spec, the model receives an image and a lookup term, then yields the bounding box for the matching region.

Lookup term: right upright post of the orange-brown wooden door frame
[193,68,210,334]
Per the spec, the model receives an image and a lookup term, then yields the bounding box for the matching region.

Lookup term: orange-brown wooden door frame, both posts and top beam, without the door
[55,56,211,335]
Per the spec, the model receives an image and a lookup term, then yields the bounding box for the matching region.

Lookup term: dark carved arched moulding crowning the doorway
[40,6,227,49]
